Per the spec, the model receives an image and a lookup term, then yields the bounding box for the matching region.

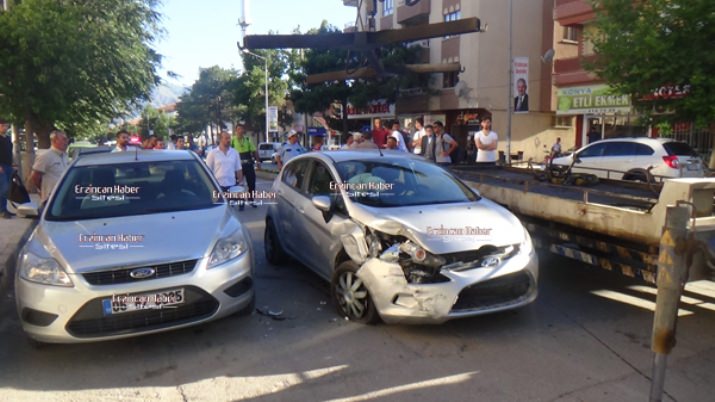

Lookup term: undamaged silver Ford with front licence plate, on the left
[15,151,255,343]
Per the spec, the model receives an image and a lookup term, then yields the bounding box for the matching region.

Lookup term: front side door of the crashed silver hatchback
[298,160,349,279]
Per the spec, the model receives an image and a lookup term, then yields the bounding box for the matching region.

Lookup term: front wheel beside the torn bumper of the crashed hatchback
[330,261,380,324]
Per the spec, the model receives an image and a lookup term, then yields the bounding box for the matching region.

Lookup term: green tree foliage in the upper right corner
[588,0,715,125]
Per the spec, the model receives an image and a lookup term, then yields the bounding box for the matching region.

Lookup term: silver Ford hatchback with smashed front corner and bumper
[264,150,538,323]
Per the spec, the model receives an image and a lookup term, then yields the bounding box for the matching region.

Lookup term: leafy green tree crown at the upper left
[0,0,160,147]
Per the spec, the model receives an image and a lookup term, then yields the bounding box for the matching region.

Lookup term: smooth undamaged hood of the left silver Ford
[33,207,235,273]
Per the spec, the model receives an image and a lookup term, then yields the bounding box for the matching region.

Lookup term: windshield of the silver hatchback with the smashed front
[336,158,479,207]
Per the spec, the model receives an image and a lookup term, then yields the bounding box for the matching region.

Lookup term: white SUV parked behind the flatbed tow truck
[553,137,705,181]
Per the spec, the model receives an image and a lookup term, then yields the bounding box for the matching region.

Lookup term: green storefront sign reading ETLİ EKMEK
[556,84,631,115]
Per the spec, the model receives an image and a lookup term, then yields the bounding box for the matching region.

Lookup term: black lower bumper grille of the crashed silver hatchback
[452,271,532,311]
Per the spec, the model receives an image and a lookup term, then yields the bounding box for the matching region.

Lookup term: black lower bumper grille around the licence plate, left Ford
[66,286,219,338]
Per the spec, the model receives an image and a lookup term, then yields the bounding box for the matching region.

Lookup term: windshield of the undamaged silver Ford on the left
[45,160,216,220]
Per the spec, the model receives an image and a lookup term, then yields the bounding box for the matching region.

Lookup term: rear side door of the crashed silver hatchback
[275,159,310,261]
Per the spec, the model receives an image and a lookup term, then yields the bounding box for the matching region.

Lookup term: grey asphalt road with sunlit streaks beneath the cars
[0,177,715,401]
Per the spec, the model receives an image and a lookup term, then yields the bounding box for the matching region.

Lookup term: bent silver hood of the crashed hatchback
[351,198,524,254]
